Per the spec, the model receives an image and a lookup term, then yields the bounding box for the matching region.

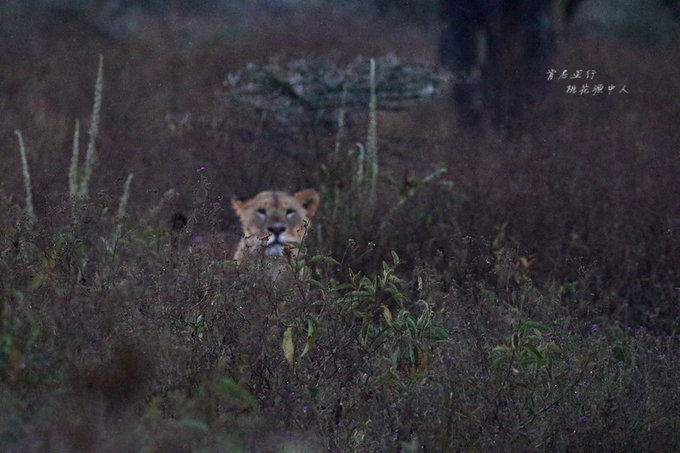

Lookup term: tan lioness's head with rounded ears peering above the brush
[232,189,319,261]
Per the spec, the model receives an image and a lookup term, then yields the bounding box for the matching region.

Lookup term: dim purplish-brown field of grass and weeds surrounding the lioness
[0,2,680,452]
